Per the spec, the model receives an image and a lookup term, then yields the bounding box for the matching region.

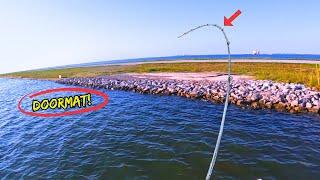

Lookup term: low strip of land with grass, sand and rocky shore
[2,60,320,113]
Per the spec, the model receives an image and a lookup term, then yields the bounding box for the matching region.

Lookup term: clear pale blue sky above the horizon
[0,0,320,73]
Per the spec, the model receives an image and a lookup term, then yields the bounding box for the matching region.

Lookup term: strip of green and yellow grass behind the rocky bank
[0,62,320,89]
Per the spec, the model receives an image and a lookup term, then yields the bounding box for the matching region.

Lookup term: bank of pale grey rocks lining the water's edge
[57,75,320,113]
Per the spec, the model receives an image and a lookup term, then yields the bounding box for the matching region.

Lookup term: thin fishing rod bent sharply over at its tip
[178,24,232,180]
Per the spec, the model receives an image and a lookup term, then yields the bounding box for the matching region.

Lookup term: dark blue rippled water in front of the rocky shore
[0,79,320,179]
